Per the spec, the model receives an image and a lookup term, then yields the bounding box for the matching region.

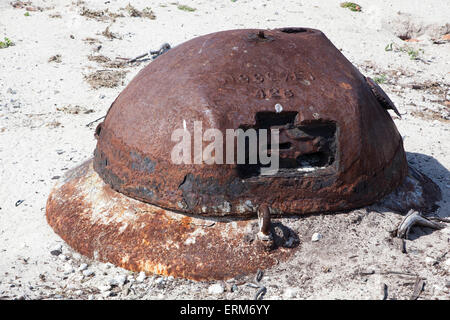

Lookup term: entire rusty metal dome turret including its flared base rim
[46,28,439,280]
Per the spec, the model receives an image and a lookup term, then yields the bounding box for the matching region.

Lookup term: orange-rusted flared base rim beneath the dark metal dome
[46,160,298,280]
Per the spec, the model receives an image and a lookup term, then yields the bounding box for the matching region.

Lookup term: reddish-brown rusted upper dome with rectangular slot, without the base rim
[94,28,407,216]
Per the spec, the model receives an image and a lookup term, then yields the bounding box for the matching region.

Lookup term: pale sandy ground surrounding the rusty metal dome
[0,0,450,299]
